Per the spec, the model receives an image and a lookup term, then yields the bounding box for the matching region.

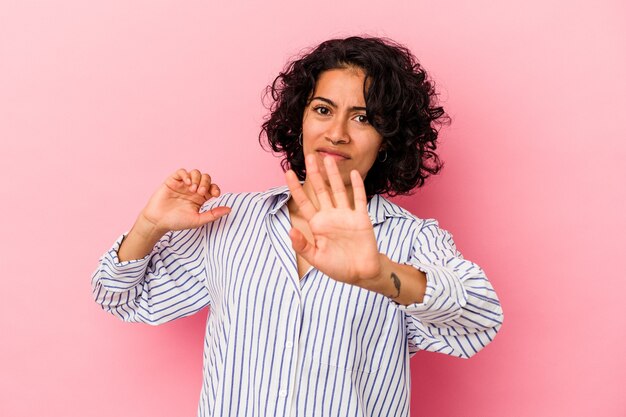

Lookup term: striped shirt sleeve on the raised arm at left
[91,200,221,325]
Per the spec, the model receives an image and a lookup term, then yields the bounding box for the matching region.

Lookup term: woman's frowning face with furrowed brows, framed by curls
[302,68,382,185]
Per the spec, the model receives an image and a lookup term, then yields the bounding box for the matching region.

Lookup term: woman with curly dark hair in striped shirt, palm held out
[92,37,503,416]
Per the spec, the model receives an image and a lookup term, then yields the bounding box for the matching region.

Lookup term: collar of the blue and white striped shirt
[251,185,413,225]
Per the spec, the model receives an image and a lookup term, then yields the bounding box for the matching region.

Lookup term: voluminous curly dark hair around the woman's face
[259,36,450,197]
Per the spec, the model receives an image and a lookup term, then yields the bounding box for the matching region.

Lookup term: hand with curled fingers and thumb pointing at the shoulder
[140,168,230,235]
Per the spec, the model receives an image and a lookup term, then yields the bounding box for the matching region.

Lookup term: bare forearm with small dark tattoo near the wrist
[362,253,426,305]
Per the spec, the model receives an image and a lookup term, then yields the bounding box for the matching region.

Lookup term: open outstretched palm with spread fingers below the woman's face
[285,155,381,285]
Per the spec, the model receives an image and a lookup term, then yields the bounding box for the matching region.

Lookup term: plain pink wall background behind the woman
[0,0,626,417]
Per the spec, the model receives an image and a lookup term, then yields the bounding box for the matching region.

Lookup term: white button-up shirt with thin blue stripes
[92,186,503,417]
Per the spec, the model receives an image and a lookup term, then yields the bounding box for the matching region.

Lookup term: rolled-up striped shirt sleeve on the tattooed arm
[397,219,504,358]
